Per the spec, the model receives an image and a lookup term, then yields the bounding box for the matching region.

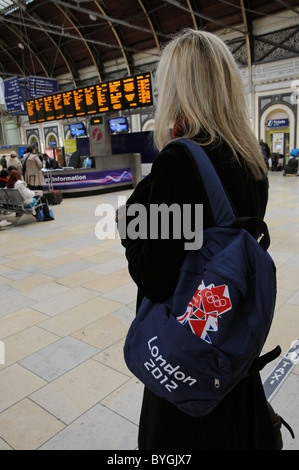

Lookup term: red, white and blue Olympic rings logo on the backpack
[177,281,232,343]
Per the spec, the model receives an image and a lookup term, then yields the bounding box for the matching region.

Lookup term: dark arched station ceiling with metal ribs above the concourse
[0,0,299,86]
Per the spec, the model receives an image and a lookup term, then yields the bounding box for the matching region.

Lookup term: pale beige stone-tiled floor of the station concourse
[0,172,299,450]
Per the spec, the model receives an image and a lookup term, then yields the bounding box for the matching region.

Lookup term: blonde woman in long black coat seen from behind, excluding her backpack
[119,29,272,452]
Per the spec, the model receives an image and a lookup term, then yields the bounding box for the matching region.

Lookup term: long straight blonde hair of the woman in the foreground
[154,28,265,179]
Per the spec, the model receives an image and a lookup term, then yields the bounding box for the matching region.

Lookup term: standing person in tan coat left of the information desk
[23,146,46,191]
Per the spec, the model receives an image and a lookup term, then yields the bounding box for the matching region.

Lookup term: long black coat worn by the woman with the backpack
[122,140,271,451]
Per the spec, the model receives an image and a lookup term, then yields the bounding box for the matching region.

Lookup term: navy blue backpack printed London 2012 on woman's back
[124,139,276,416]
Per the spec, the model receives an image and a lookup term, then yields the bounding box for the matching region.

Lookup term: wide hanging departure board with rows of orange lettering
[27,72,153,124]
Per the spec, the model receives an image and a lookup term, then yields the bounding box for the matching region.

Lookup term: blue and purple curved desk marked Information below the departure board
[43,153,142,196]
